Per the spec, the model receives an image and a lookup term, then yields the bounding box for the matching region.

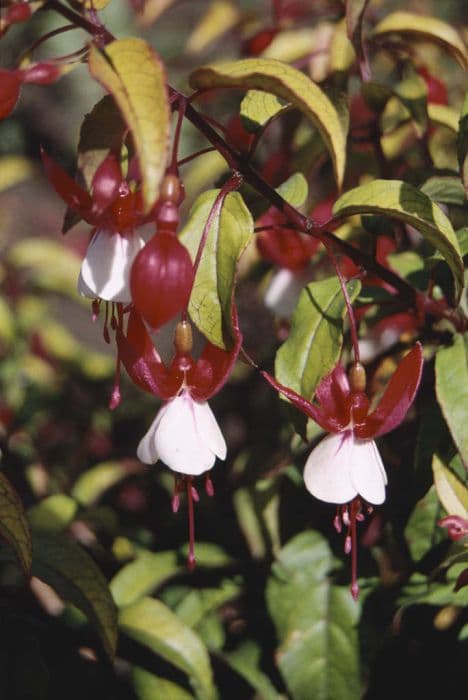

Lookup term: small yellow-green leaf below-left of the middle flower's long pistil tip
[109,552,181,608]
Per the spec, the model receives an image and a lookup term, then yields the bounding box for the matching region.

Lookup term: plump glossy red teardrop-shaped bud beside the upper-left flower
[130,231,193,329]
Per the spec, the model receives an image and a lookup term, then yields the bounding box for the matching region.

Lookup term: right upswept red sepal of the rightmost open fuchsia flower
[354,343,424,438]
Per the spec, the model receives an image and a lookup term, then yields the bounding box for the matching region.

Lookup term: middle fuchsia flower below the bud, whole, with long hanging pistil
[116,309,242,568]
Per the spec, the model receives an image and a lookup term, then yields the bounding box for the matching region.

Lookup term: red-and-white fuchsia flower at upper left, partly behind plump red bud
[42,151,151,303]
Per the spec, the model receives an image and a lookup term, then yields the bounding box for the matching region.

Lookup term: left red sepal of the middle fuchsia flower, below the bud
[116,310,184,399]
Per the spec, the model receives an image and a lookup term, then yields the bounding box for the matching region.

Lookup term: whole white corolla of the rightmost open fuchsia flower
[304,430,387,505]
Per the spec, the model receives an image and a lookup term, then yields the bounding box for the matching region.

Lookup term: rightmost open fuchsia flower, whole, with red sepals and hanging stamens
[263,343,423,598]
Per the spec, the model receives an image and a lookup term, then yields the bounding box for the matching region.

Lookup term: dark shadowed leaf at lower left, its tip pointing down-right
[32,532,117,659]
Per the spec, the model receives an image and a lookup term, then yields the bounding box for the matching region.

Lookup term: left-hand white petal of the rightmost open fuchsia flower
[304,433,358,503]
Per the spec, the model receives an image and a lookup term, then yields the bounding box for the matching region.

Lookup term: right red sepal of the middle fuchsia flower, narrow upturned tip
[188,304,242,401]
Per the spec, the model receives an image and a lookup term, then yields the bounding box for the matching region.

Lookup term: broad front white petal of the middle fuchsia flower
[155,394,216,476]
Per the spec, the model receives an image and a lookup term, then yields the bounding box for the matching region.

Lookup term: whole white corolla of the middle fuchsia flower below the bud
[137,391,226,476]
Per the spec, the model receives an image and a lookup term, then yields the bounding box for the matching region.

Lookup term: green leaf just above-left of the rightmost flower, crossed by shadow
[275,277,361,399]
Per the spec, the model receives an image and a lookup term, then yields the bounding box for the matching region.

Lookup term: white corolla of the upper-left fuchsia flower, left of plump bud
[78,229,145,303]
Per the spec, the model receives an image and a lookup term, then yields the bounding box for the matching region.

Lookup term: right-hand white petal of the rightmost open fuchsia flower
[351,439,387,506]
